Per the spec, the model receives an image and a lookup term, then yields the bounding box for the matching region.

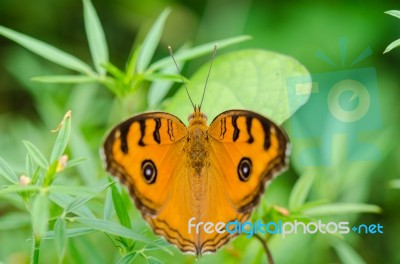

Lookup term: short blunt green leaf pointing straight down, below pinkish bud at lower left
[31,193,49,239]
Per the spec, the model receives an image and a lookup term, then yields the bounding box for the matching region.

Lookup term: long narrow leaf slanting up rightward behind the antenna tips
[149,36,251,72]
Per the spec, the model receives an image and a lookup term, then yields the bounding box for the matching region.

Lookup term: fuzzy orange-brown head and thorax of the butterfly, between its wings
[186,107,209,176]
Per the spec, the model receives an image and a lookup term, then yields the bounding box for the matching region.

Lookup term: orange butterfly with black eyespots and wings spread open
[103,46,290,255]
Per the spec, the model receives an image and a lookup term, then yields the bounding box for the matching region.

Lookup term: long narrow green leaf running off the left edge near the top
[0,26,93,75]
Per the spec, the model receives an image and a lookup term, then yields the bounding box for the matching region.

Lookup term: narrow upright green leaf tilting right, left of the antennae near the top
[136,8,171,73]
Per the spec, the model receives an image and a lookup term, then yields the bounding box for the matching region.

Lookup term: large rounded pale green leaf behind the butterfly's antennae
[166,50,311,123]
